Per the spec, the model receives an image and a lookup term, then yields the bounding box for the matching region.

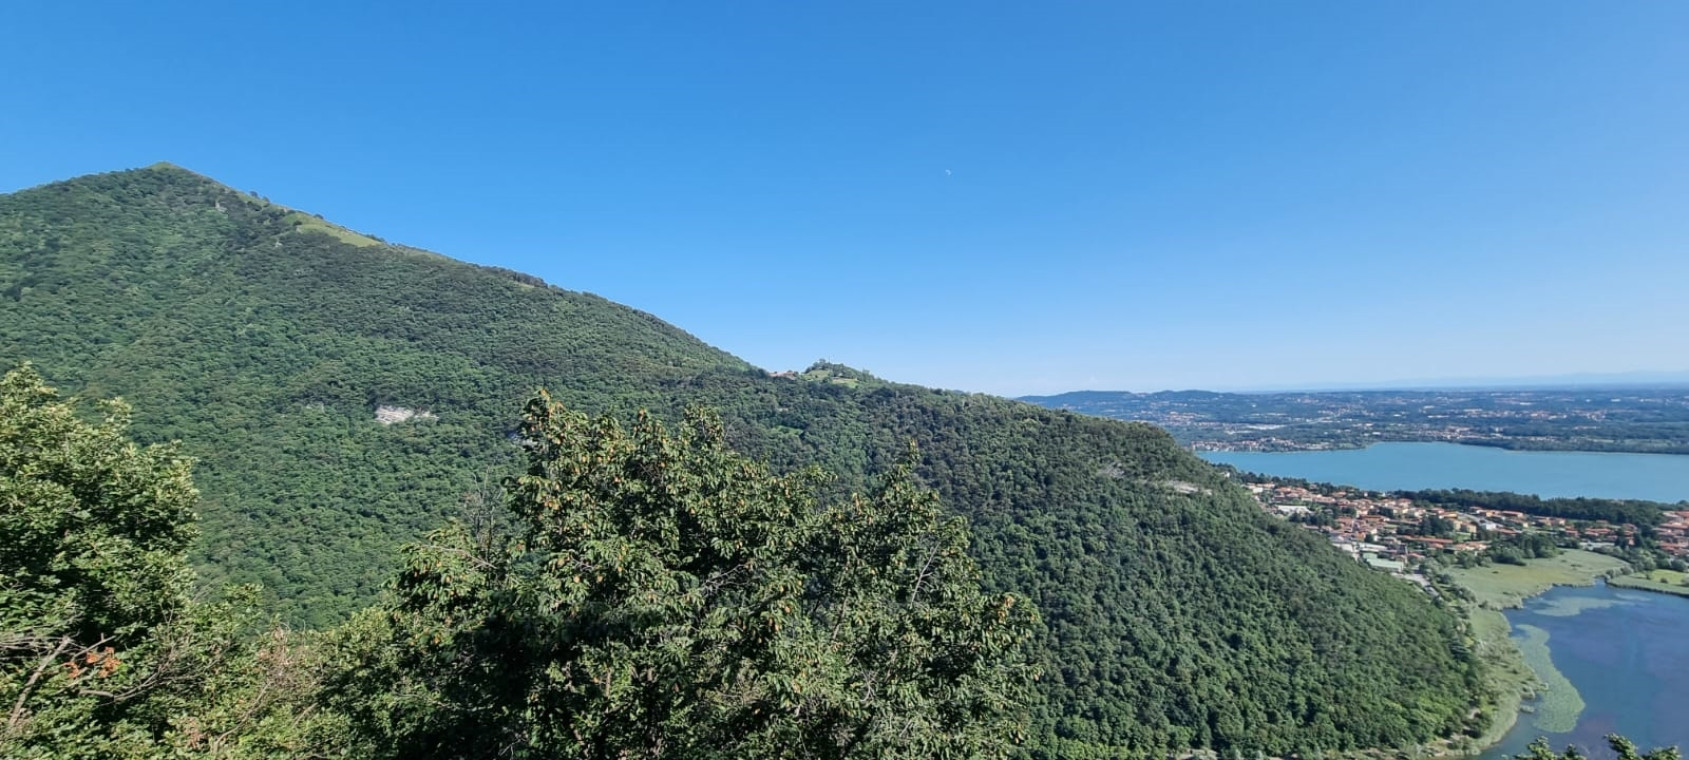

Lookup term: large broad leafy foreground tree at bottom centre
[334,395,1034,758]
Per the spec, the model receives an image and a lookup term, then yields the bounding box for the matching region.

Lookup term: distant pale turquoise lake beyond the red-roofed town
[1201,442,1689,502]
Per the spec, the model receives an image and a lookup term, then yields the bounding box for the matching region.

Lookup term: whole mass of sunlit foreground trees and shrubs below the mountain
[0,366,1037,760]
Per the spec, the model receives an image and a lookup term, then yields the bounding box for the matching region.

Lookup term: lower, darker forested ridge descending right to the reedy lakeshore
[678,375,1481,757]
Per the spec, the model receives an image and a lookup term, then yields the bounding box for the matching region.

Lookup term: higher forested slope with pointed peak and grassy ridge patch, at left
[0,166,745,625]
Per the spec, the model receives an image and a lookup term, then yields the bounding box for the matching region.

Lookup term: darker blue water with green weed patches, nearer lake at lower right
[1481,584,1689,760]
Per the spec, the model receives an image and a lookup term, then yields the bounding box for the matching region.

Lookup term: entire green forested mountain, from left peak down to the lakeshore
[0,166,1478,757]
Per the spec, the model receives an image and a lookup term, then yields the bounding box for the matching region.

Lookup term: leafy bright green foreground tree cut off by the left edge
[0,366,196,757]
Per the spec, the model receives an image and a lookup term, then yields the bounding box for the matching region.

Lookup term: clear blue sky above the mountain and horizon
[0,0,1689,395]
